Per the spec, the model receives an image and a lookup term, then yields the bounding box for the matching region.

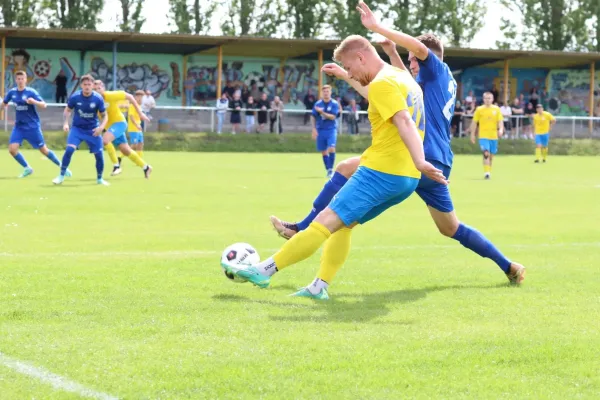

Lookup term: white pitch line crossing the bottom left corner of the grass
[0,352,118,400]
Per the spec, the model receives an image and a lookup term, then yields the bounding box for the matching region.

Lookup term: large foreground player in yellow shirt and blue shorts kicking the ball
[221,35,447,300]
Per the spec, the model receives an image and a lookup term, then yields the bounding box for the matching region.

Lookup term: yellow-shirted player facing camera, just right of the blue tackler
[471,92,504,179]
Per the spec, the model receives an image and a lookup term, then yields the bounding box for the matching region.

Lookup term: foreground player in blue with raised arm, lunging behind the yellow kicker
[271,2,525,290]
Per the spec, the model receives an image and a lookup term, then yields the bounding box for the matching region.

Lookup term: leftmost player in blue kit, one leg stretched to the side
[3,71,71,178]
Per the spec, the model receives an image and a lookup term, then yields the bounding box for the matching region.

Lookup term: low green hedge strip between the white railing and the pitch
[0,132,600,156]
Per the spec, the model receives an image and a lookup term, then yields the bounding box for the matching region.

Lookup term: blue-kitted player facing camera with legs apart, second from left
[52,75,108,186]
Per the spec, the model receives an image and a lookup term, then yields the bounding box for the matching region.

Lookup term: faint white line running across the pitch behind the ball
[0,242,600,258]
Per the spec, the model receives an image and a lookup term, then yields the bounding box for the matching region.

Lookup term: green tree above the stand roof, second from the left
[42,0,104,30]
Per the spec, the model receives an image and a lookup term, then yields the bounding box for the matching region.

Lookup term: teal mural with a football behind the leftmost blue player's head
[4,49,79,102]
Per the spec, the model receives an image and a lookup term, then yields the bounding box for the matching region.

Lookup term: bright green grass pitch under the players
[0,151,600,400]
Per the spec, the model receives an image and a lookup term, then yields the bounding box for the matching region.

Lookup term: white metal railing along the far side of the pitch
[4,104,600,139]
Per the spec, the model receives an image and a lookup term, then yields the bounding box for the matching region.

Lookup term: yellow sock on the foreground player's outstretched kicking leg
[273,222,331,270]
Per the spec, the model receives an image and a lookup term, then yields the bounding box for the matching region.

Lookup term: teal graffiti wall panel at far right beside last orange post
[547,69,600,116]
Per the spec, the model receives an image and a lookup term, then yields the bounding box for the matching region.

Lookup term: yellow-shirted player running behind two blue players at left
[94,80,152,178]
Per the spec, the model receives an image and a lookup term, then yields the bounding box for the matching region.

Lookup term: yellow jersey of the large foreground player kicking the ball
[360,66,425,179]
